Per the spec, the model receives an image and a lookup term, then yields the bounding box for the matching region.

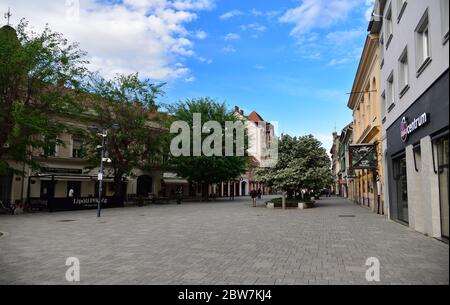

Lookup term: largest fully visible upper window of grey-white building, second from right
[416,10,431,76]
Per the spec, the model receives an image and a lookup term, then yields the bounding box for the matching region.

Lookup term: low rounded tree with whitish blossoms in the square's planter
[257,135,333,196]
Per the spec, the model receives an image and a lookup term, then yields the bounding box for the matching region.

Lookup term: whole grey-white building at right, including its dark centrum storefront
[373,0,449,241]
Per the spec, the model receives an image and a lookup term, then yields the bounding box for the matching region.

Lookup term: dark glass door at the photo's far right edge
[436,136,450,239]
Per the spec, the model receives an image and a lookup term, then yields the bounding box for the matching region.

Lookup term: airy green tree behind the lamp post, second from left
[85,74,163,196]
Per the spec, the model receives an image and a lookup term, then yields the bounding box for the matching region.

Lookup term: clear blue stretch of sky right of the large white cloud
[160,0,374,148]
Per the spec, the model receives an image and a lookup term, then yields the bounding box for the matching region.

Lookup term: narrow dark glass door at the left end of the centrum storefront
[393,156,409,223]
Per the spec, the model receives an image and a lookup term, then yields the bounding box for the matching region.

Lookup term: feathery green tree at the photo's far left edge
[0,21,87,174]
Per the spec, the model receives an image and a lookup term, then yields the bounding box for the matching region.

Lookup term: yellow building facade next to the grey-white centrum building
[348,33,385,214]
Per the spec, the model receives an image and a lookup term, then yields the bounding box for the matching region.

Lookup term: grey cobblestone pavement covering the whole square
[0,198,449,285]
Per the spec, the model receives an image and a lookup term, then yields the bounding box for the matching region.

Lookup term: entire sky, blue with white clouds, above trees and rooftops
[0,0,372,148]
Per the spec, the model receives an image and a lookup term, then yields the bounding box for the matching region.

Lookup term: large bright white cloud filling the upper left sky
[0,0,214,80]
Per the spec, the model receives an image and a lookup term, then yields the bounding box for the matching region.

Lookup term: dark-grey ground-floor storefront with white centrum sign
[386,71,449,240]
